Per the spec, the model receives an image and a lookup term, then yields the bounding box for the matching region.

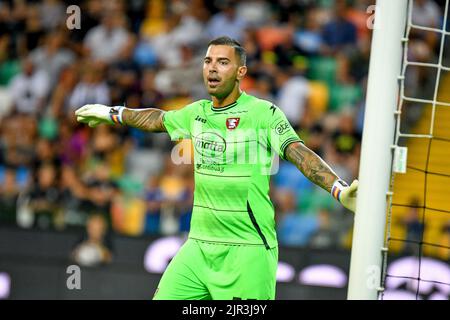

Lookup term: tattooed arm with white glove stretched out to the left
[75,104,166,132]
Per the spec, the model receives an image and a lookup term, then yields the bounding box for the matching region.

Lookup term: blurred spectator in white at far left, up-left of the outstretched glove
[9,57,50,116]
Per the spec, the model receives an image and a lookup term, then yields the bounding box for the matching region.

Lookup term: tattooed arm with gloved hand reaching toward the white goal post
[285,142,358,212]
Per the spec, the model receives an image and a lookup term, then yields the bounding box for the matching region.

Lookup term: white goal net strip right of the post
[379,0,450,300]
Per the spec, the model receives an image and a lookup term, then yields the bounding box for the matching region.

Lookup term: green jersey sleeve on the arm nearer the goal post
[268,105,303,160]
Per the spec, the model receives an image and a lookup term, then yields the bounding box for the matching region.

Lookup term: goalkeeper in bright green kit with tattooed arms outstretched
[75,37,358,300]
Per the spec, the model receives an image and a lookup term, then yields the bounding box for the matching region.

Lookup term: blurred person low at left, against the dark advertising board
[71,214,113,267]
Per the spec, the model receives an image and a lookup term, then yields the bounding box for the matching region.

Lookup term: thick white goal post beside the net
[347,0,408,300]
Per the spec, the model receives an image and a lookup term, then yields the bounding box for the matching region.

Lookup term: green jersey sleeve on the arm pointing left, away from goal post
[163,103,196,140]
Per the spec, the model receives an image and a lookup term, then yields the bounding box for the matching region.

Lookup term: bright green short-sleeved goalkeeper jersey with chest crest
[163,92,301,248]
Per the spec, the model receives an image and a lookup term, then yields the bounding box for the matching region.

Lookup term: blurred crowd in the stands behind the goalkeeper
[0,0,442,259]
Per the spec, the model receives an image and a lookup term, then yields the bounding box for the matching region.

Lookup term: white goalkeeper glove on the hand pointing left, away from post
[75,104,125,127]
